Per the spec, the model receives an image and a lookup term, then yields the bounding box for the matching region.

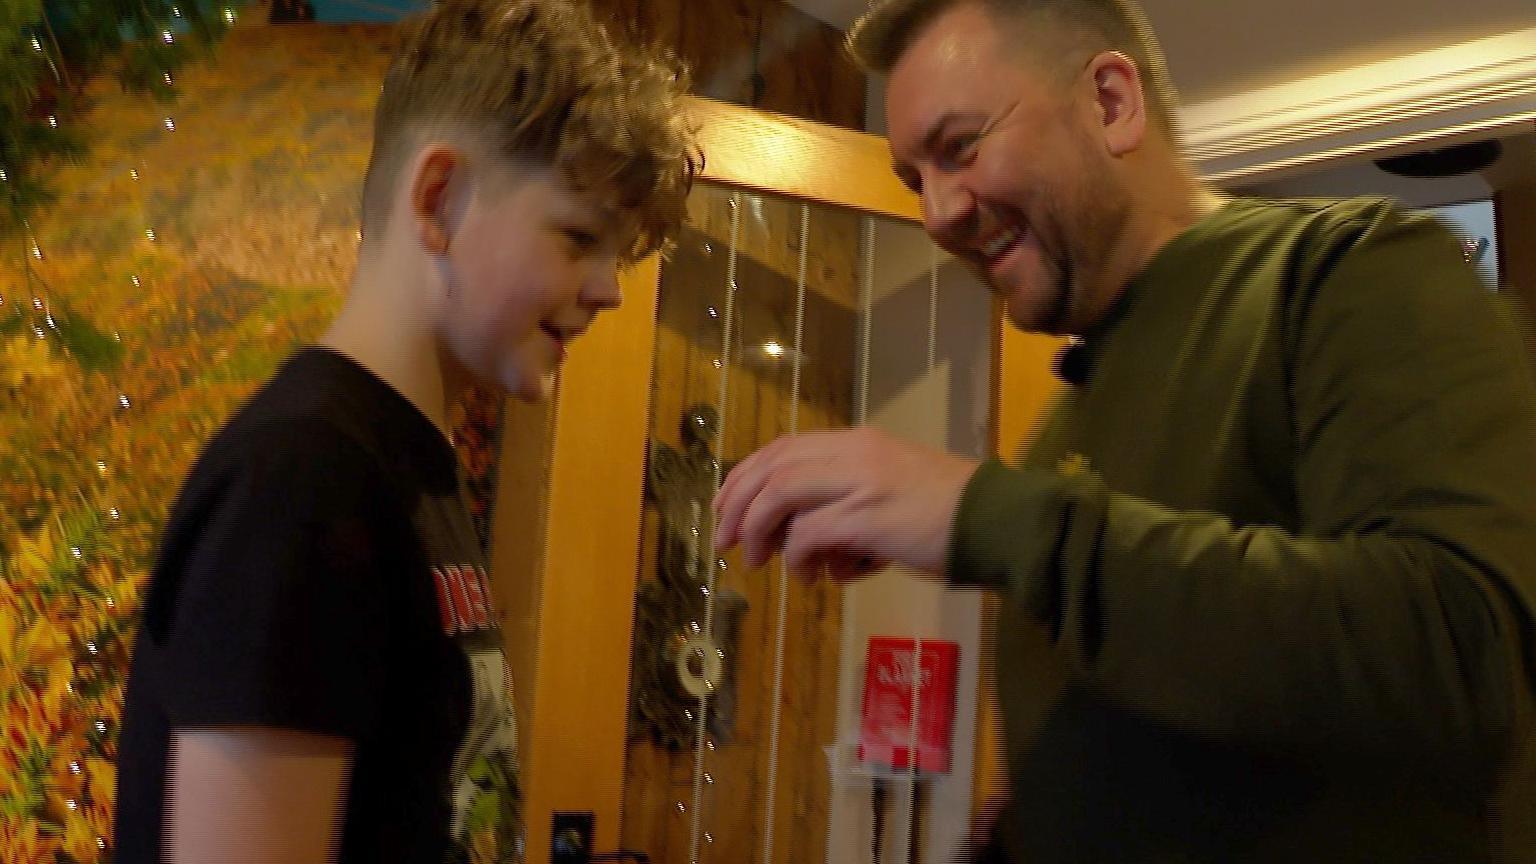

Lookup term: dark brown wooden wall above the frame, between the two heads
[591,0,865,129]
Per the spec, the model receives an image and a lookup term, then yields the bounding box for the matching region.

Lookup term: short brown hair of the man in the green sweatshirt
[848,0,1178,138]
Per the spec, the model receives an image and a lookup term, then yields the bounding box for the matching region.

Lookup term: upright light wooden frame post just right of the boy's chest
[508,252,657,861]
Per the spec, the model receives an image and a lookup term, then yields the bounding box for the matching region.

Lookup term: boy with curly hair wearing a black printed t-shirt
[114,0,697,864]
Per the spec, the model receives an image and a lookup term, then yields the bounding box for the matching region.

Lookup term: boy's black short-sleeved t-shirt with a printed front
[114,349,521,864]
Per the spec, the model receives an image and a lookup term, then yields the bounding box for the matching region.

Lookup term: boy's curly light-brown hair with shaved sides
[362,0,702,261]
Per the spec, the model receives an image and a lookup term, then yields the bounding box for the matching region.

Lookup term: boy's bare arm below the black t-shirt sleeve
[164,727,352,864]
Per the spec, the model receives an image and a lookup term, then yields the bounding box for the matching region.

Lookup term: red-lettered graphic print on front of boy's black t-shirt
[432,564,522,864]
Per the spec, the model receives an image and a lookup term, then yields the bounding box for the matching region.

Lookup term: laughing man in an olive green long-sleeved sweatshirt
[716,0,1536,864]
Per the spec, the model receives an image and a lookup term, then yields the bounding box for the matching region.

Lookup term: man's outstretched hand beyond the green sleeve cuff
[714,427,980,580]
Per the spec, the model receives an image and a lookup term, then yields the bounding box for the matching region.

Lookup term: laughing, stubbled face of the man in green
[886,5,1124,334]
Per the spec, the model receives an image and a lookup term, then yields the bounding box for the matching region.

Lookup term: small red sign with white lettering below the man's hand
[859,636,960,773]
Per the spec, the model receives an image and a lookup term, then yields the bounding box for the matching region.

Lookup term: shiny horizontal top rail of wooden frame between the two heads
[691,98,922,221]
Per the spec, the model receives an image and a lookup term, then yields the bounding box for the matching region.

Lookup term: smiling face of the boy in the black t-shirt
[438,172,619,401]
